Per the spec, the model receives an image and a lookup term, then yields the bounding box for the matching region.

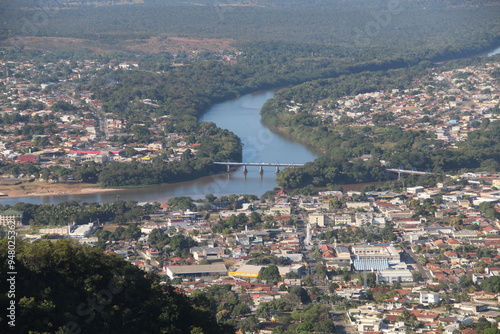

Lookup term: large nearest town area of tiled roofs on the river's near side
[9,173,500,333]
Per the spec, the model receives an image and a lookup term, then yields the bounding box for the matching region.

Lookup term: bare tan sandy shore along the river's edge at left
[0,181,119,198]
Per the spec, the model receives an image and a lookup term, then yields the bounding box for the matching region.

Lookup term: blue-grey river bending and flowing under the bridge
[0,91,319,205]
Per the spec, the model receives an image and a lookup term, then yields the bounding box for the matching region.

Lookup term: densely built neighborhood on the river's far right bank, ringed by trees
[288,63,500,148]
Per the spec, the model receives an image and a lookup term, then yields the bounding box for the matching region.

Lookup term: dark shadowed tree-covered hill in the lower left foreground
[0,239,230,334]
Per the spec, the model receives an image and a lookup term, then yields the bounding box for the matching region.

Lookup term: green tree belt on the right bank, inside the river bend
[262,63,500,188]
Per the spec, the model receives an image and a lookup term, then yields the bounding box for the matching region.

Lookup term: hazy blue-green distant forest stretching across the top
[0,0,500,56]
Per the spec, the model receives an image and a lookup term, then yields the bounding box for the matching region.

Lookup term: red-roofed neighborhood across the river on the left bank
[0,51,236,182]
